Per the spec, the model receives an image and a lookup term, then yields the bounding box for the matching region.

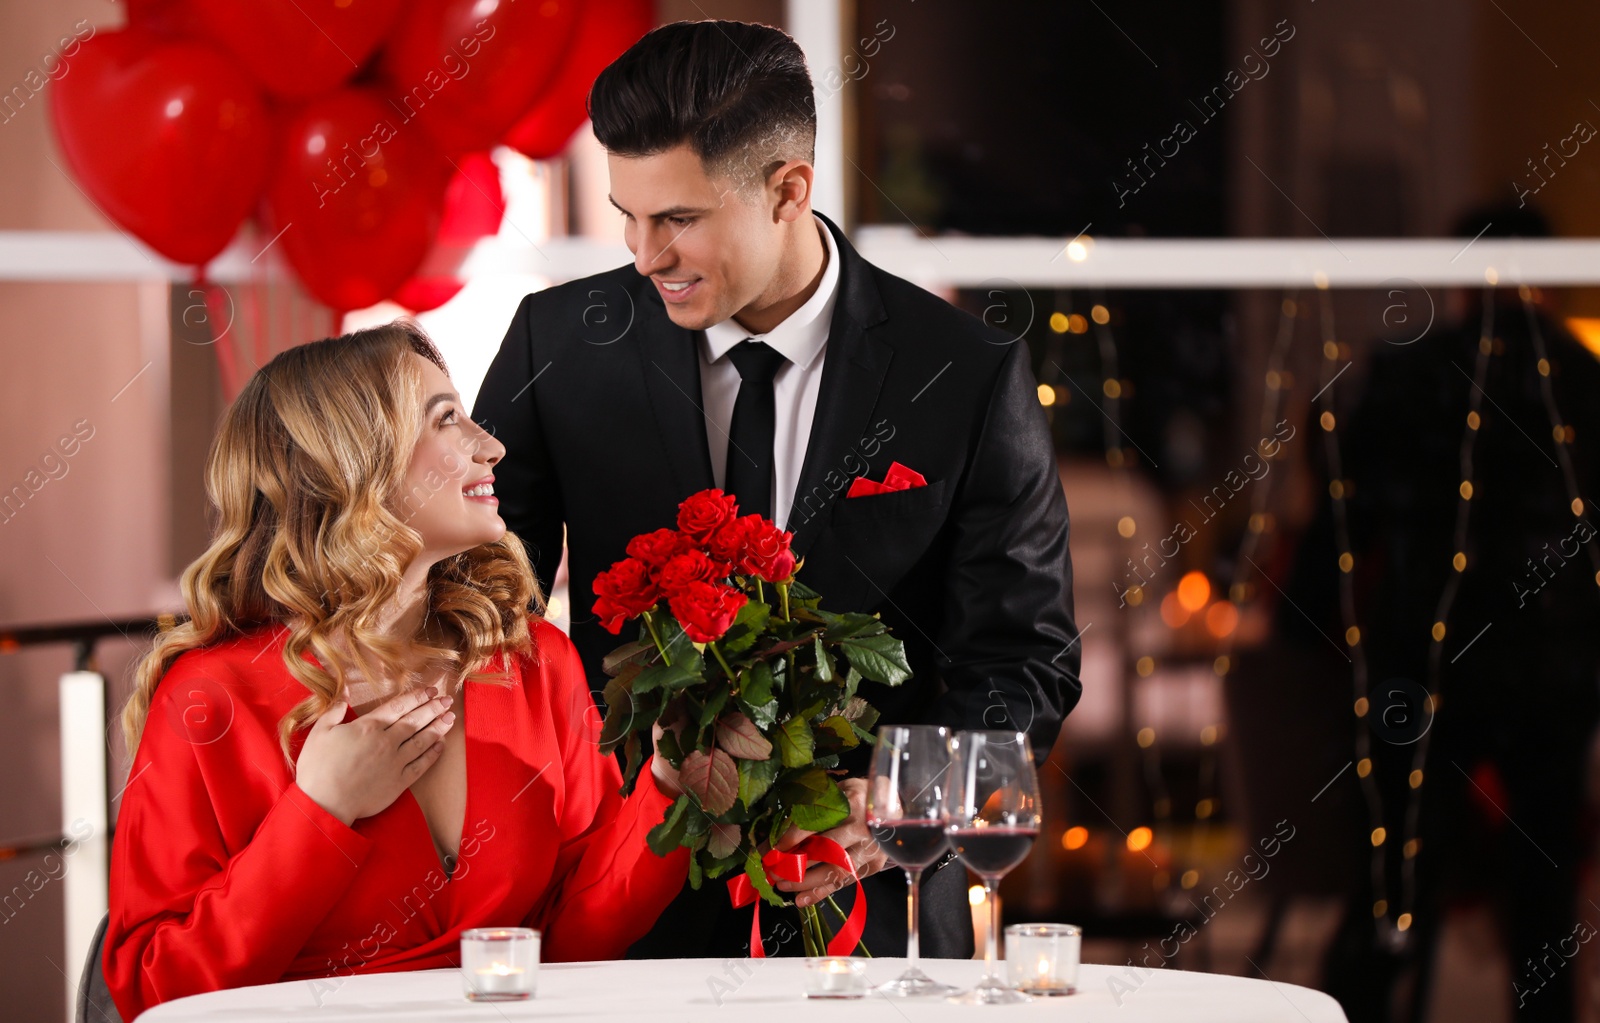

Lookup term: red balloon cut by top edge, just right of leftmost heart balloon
[189,0,400,99]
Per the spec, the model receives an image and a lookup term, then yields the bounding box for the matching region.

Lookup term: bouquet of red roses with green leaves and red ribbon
[594,490,910,954]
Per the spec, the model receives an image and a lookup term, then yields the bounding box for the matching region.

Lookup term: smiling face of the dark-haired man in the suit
[606,146,782,330]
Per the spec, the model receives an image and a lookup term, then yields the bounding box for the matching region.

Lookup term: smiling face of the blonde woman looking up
[395,352,506,564]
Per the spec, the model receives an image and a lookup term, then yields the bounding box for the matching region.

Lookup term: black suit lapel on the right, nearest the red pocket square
[784,215,894,557]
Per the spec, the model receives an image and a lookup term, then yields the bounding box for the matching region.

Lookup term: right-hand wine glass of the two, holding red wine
[947,732,1040,1005]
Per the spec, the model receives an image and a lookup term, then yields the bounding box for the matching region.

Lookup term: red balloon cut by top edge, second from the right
[384,0,578,154]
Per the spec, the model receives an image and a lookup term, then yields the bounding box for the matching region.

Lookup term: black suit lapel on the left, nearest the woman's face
[635,280,717,501]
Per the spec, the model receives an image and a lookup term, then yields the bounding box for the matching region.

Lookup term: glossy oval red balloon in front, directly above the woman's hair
[264,88,448,312]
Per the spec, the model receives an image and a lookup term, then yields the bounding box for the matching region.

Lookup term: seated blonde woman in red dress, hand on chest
[102,322,688,1023]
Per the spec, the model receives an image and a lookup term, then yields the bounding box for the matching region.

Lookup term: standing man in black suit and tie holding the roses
[474,22,1080,957]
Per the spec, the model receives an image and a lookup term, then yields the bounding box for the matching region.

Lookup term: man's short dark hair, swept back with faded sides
[589,21,816,179]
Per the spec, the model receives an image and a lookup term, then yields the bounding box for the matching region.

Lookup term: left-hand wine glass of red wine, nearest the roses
[867,725,955,997]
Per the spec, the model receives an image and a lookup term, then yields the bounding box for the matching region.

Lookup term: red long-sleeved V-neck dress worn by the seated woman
[102,621,688,1023]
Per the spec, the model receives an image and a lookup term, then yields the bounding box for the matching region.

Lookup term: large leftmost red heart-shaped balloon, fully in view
[51,29,272,266]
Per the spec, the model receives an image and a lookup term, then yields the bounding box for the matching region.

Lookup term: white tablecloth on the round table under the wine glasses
[139,959,1344,1023]
